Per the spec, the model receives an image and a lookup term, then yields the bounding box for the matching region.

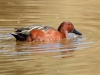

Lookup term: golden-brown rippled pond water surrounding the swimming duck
[0,0,100,75]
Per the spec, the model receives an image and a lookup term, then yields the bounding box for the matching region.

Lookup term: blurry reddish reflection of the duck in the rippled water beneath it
[15,39,75,57]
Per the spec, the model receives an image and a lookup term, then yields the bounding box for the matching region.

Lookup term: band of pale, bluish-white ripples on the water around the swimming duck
[0,28,93,57]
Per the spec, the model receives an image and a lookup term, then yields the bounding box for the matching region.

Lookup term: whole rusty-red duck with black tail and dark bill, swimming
[11,21,82,42]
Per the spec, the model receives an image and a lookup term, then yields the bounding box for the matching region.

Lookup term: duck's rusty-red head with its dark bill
[58,21,82,35]
